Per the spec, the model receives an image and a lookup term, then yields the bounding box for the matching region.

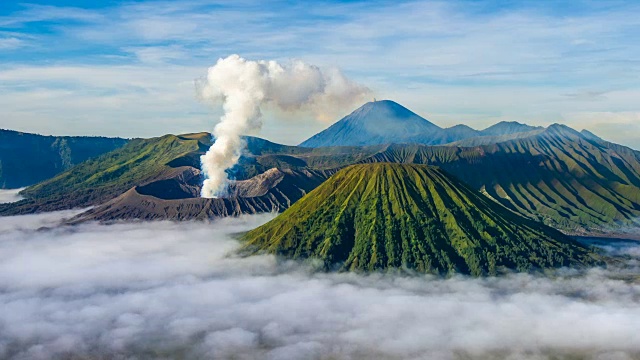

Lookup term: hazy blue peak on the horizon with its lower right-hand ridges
[300,100,542,147]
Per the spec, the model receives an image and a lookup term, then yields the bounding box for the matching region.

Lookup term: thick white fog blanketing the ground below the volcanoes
[0,212,640,359]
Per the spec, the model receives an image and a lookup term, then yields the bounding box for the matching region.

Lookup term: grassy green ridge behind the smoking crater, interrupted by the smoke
[0,133,379,215]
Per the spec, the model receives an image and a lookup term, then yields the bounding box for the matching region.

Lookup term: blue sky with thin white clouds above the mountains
[0,0,640,149]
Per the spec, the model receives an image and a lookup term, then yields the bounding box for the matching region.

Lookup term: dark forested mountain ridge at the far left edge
[0,129,128,189]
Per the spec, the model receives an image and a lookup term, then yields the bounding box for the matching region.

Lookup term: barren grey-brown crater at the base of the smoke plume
[70,166,333,223]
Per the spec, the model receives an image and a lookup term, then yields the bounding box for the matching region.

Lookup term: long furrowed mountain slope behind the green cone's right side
[361,124,640,233]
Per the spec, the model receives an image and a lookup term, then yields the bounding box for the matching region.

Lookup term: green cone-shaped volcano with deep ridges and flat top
[243,163,599,276]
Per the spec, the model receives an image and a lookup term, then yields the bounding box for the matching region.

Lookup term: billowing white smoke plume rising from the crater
[197,55,369,197]
